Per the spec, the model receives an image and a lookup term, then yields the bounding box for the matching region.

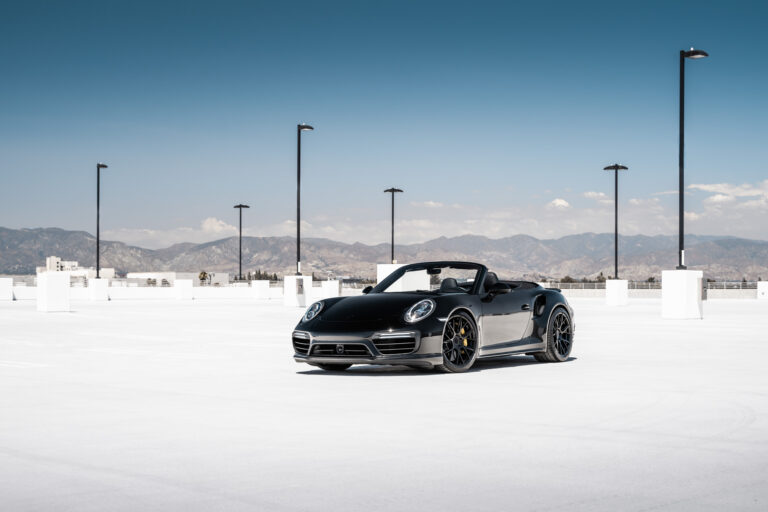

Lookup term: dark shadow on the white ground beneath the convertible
[296,355,578,377]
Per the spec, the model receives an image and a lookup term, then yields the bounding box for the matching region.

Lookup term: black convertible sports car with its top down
[293,261,574,372]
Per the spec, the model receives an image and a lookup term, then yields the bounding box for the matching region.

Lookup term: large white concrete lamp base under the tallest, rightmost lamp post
[661,270,704,319]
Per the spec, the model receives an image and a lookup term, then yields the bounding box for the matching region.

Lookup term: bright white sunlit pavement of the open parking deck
[0,299,768,512]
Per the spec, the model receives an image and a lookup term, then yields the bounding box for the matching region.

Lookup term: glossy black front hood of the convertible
[320,293,434,323]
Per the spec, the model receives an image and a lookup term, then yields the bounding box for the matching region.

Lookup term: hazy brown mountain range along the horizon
[0,228,768,279]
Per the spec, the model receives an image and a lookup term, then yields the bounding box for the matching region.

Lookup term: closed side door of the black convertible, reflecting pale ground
[481,289,531,355]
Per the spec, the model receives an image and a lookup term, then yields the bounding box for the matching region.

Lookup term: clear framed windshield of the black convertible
[374,265,480,293]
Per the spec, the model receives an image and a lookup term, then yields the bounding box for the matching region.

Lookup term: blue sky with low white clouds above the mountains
[0,1,768,247]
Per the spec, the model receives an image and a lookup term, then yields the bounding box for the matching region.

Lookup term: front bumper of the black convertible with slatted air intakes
[292,329,443,368]
